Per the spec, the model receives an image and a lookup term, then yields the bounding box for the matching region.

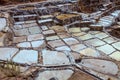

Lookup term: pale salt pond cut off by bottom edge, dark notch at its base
[35,69,73,80]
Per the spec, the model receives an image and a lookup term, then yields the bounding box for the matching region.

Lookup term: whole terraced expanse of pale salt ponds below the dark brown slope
[0,1,120,80]
